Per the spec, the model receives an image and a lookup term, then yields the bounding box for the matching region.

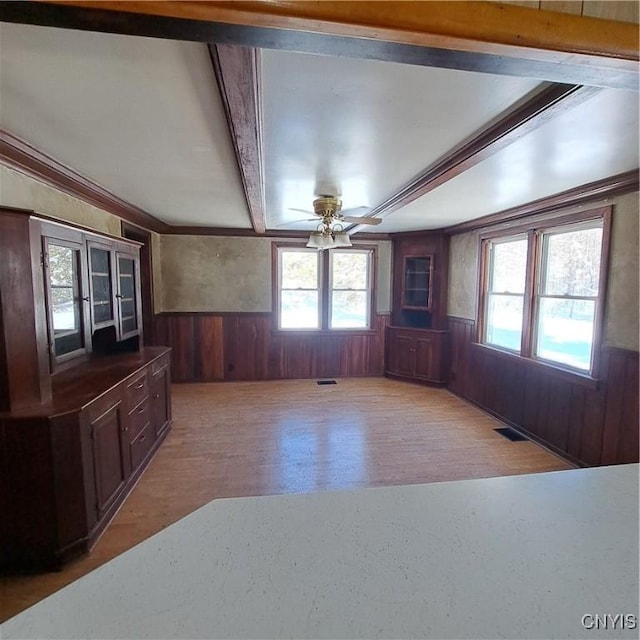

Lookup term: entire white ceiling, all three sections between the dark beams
[0,24,639,232]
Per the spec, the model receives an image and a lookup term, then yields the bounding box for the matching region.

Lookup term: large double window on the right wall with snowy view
[479,210,610,375]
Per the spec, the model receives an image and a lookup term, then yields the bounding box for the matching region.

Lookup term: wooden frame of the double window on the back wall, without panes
[271,242,378,336]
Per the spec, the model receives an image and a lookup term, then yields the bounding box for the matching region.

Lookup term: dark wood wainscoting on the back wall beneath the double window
[154,313,389,382]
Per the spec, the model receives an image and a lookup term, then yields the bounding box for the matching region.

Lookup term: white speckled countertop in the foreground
[0,465,639,639]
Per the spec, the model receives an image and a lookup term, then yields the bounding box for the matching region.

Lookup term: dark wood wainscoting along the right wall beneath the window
[449,317,638,466]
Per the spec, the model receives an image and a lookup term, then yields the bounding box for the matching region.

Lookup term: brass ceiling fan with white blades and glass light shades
[294,195,382,250]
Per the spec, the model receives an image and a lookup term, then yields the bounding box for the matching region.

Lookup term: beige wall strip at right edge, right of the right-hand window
[603,193,640,351]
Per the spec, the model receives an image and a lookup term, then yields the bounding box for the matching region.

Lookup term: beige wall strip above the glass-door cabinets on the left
[0,165,122,236]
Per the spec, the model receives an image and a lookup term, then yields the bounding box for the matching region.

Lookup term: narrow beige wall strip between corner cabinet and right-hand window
[447,233,478,320]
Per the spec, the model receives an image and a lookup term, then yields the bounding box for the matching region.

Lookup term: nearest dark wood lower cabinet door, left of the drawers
[91,402,128,518]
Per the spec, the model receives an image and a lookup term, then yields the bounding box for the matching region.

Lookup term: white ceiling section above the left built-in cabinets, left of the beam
[0,23,251,228]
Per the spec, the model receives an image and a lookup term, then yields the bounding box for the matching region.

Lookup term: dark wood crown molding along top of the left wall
[0,129,167,233]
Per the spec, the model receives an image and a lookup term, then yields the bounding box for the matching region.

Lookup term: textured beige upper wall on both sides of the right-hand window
[447,193,640,351]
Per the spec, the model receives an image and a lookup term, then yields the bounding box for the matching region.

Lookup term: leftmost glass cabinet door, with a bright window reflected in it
[44,238,86,368]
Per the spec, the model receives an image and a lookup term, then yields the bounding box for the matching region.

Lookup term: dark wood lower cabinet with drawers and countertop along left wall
[0,347,171,569]
